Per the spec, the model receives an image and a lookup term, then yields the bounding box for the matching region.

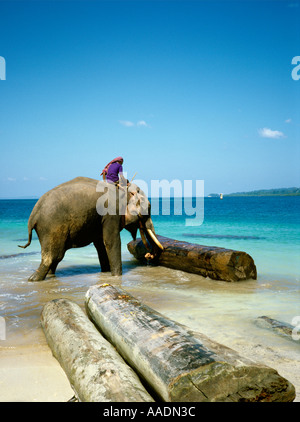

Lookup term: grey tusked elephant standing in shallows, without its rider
[18,177,163,281]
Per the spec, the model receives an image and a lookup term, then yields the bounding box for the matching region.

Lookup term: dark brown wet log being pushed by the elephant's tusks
[127,236,257,281]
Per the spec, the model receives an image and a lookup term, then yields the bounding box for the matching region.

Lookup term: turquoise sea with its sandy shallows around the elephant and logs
[0,197,300,398]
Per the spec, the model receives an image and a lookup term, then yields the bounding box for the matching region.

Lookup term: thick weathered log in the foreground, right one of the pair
[86,284,295,402]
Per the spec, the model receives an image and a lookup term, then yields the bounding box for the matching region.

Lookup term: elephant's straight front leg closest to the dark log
[102,221,122,275]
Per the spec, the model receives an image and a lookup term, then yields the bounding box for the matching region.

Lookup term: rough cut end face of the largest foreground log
[169,362,295,402]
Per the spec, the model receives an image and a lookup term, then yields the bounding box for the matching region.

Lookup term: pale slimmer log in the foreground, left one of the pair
[41,299,153,402]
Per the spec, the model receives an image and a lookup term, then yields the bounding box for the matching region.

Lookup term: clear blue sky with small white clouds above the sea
[0,0,300,197]
